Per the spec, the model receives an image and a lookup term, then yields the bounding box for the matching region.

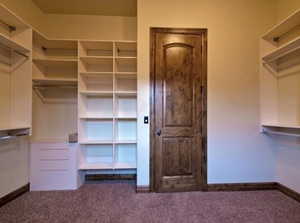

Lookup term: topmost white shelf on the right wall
[262,10,300,43]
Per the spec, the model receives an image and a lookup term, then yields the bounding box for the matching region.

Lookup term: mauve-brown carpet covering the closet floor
[0,183,300,223]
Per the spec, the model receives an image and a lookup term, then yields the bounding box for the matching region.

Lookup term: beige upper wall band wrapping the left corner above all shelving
[0,0,137,40]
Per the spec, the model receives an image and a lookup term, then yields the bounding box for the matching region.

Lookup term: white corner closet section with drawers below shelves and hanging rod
[30,32,82,190]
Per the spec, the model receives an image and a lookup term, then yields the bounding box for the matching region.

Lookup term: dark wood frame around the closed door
[150,27,207,192]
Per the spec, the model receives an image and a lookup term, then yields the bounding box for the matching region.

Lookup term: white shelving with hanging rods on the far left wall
[0,4,32,133]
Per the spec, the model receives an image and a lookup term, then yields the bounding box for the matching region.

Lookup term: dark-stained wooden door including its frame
[150,28,207,192]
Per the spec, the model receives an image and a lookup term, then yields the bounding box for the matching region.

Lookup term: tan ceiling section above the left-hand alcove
[33,0,137,16]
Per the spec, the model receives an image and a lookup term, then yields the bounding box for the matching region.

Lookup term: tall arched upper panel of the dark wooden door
[162,43,193,127]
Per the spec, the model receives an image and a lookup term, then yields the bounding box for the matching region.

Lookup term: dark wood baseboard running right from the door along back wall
[206,182,277,191]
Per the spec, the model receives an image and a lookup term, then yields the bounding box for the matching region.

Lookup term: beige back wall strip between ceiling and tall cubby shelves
[45,14,137,40]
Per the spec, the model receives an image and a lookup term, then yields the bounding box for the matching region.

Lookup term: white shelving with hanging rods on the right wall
[261,10,300,136]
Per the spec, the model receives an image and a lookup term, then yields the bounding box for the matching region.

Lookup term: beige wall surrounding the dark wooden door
[138,0,276,185]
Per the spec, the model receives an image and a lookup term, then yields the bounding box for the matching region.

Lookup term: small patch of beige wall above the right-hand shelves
[277,0,300,22]
